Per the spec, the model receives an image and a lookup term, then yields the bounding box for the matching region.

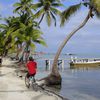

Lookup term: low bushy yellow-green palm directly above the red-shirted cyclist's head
[19,24,46,61]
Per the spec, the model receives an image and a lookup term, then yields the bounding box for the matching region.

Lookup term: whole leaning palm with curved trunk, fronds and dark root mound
[38,0,100,84]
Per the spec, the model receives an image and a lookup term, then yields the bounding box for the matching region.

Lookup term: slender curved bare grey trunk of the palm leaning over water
[51,9,92,76]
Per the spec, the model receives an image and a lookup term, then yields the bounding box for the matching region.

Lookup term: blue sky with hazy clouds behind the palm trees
[0,0,100,57]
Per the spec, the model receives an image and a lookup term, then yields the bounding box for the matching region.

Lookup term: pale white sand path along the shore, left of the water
[0,59,61,100]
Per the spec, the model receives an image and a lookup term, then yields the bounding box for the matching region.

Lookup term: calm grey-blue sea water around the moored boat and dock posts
[35,54,100,100]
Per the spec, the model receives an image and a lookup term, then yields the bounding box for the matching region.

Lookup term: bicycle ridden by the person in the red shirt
[25,74,38,91]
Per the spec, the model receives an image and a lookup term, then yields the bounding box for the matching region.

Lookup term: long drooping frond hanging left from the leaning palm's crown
[61,4,81,26]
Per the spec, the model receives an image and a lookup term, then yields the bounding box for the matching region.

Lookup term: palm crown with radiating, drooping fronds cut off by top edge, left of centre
[33,0,63,26]
